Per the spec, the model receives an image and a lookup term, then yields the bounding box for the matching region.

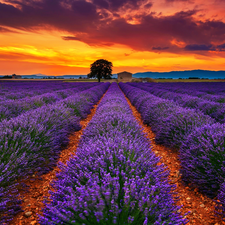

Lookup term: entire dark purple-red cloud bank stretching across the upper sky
[0,0,225,52]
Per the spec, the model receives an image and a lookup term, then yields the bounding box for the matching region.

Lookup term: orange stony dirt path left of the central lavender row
[9,91,107,225]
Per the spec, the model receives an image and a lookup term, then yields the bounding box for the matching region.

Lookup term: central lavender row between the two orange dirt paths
[40,83,186,225]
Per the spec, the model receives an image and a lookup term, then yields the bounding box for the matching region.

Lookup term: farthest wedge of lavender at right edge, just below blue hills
[143,82,225,103]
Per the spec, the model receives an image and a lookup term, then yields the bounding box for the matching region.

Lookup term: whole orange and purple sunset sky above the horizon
[0,0,225,75]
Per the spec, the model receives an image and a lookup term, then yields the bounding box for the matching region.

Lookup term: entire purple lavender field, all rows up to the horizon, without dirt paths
[0,81,225,225]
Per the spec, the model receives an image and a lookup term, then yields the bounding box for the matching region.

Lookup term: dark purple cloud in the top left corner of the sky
[0,0,99,32]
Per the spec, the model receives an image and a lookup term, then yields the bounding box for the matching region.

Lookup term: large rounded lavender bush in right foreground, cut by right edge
[180,123,225,197]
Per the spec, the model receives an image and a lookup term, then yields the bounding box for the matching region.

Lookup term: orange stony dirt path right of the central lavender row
[125,92,225,225]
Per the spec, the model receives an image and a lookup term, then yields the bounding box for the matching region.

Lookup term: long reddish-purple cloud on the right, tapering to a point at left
[74,11,225,51]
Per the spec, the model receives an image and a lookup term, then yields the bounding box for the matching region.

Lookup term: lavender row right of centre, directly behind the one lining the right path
[130,83,225,123]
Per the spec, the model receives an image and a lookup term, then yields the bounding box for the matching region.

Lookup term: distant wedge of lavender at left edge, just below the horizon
[0,81,85,102]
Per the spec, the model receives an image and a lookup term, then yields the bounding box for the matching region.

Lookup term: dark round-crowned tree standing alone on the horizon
[88,59,113,82]
